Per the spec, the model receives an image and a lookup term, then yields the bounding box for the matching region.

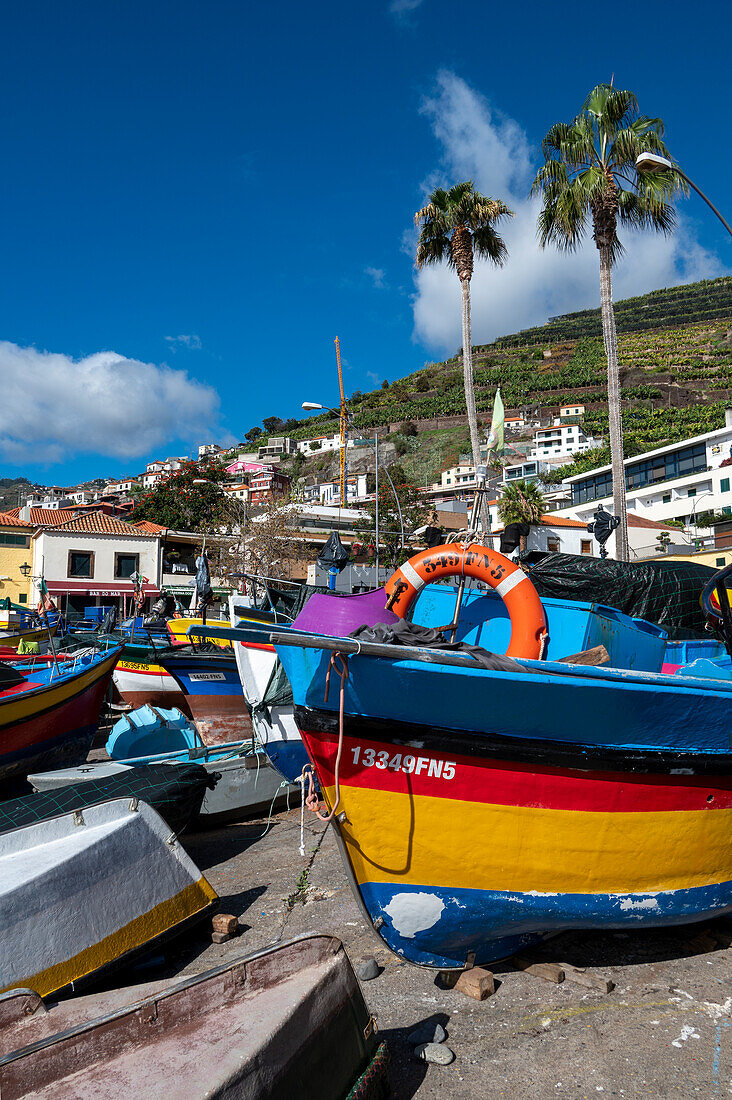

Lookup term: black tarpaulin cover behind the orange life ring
[521,551,715,641]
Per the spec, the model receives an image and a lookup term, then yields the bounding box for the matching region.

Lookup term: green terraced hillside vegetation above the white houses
[250,277,732,482]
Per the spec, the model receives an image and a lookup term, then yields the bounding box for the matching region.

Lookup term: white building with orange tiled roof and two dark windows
[33,513,162,615]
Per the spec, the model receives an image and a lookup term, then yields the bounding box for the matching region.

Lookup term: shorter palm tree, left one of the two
[414,179,513,503]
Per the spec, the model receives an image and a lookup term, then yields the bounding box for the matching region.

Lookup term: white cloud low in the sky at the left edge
[0,341,219,463]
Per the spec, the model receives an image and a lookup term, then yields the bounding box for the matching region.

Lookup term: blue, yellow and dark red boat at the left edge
[0,647,121,780]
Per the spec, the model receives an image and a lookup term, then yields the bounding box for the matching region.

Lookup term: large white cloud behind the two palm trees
[414,72,724,350]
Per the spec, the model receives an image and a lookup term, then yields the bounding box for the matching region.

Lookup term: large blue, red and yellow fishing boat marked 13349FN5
[272,547,732,968]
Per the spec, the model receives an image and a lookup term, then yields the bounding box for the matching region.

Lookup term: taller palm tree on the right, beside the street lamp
[532,84,686,561]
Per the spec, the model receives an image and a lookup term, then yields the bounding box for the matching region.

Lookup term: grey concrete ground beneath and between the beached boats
[107,810,732,1100]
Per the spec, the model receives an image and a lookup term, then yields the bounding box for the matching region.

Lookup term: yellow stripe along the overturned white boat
[0,876,218,997]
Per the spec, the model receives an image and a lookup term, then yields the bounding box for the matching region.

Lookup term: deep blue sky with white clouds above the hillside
[0,0,732,484]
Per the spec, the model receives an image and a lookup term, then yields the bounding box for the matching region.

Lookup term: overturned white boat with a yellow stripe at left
[0,798,217,997]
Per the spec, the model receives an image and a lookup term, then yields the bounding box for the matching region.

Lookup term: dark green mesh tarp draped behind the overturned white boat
[0,763,217,834]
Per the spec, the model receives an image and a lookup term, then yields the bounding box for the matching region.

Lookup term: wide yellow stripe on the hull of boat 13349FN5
[326,785,732,893]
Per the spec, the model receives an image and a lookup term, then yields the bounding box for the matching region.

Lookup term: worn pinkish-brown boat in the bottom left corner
[0,935,390,1100]
